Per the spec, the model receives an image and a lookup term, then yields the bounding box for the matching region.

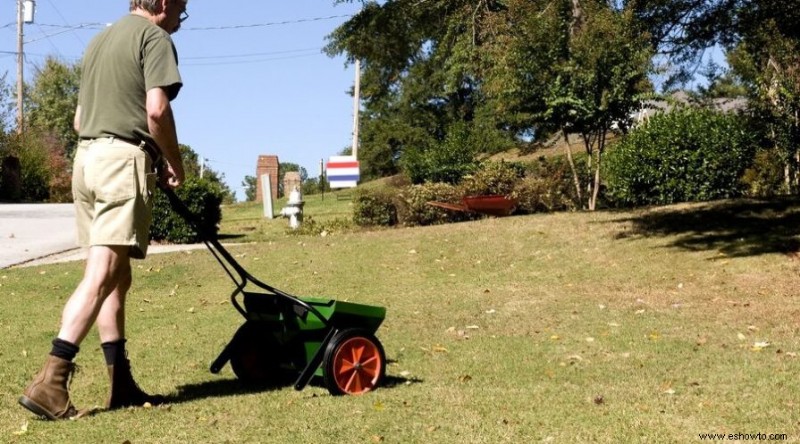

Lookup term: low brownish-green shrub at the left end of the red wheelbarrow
[397,183,479,226]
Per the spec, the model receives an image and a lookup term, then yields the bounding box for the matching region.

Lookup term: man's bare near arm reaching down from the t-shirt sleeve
[147,88,184,188]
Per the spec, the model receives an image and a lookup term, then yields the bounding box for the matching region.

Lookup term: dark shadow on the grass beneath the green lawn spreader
[166,375,423,404]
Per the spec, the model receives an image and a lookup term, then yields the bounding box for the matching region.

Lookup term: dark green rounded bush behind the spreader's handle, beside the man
[150,177,224,244]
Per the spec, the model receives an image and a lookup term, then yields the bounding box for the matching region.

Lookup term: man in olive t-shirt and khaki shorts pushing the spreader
[19,0,188,420]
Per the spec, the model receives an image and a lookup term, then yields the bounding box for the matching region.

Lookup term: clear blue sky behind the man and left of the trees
[0,0,360,200]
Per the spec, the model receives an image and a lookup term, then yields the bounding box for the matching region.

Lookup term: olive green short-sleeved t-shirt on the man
[78,15,182,146]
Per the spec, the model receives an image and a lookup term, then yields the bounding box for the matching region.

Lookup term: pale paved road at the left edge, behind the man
[0,204,79,269]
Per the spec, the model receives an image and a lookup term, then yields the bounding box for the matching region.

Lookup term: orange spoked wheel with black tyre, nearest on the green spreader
[325,329,386,395]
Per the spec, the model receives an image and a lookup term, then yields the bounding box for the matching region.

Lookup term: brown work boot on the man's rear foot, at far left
[19,355,81,420]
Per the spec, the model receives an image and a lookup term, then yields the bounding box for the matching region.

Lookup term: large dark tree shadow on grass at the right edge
[617,196,800,257]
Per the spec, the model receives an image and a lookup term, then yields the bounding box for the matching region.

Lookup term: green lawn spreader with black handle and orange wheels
[163,189,386,395]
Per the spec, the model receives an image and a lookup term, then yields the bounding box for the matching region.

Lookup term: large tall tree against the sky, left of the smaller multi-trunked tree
[326,0,503,179]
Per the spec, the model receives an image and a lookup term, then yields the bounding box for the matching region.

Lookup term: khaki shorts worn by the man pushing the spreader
[72,138,156,259]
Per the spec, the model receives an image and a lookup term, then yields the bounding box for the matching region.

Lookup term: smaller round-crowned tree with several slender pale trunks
[484,0,652,210]
